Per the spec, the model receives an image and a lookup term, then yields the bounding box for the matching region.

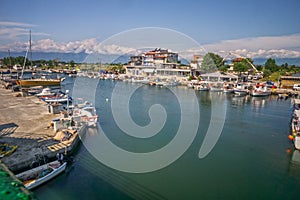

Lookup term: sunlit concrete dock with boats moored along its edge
[0,88,79,173]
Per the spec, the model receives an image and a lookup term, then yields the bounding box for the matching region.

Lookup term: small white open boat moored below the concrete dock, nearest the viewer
[16,161,67,189]
